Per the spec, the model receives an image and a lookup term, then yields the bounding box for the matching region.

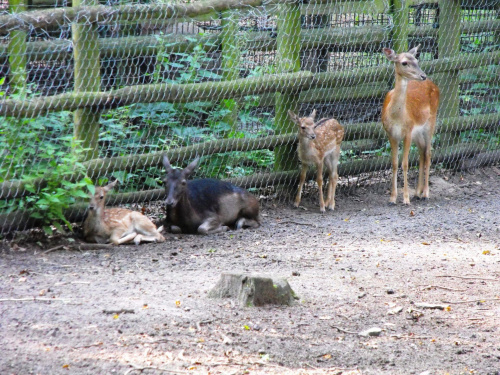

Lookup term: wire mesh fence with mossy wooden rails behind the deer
[0,0,500,233]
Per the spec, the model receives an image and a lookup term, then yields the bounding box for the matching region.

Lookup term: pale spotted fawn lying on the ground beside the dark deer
[83,180,165,245]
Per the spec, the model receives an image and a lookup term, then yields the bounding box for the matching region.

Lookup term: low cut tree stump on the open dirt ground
[208,272,297,307]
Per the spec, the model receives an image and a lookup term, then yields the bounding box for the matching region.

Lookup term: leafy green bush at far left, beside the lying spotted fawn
[0,81,93,233]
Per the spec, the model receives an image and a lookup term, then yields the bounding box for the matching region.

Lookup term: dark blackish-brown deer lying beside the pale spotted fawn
[163,156,260,234]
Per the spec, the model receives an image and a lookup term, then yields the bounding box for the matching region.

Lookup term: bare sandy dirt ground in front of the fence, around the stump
[0,167,500,375]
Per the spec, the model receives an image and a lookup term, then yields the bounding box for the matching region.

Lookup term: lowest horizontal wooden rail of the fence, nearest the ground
[0,143,500,233]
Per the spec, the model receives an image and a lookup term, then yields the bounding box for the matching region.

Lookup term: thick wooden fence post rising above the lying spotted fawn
[72,0,101,160]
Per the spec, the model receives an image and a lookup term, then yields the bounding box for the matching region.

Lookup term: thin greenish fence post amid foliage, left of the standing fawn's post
[221,10,241,136]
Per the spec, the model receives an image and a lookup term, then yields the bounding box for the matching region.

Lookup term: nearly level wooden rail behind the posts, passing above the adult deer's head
[0,20,500,62]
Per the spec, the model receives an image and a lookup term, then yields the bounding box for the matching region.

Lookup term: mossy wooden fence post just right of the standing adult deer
[434,0,460,147]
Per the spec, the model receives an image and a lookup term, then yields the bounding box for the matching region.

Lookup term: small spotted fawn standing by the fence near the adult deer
[288,110,344,212]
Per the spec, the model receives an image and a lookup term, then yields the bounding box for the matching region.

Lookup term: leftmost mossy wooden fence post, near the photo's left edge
[8,0,28,96]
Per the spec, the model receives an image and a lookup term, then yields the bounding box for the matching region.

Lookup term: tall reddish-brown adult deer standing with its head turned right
[382,46,439,205]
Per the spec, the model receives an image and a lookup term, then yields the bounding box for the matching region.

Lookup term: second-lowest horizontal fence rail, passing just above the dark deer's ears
[0,113,500,199]
